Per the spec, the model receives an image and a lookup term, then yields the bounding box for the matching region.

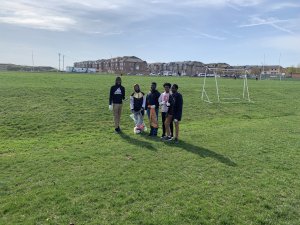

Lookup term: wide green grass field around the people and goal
[0,72,300,225]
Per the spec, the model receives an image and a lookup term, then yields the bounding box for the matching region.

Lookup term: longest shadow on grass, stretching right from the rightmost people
[165,141,237,166]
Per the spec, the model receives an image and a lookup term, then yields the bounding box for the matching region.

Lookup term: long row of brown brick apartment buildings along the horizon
[74,56,285,78]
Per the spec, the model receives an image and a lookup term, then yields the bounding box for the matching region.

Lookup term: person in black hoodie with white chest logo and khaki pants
[109,77,125,133]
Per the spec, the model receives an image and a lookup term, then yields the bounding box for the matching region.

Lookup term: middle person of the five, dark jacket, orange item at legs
[146,82,160,136]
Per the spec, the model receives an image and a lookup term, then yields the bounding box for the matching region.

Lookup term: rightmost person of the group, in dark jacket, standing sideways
[164,84,183,143]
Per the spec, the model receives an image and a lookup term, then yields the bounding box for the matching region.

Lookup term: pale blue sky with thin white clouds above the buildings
[0,0,300,68]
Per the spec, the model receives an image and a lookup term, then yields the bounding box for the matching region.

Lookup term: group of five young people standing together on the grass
[109,77,183,142]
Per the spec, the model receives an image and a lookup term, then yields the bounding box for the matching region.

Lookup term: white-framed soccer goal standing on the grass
[201,69,251,103]
